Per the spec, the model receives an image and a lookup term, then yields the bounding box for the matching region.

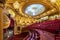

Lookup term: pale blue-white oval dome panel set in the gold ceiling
[25,4,45,16]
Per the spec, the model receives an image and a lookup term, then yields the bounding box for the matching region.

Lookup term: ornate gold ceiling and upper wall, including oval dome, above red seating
[0,0,60,32]
